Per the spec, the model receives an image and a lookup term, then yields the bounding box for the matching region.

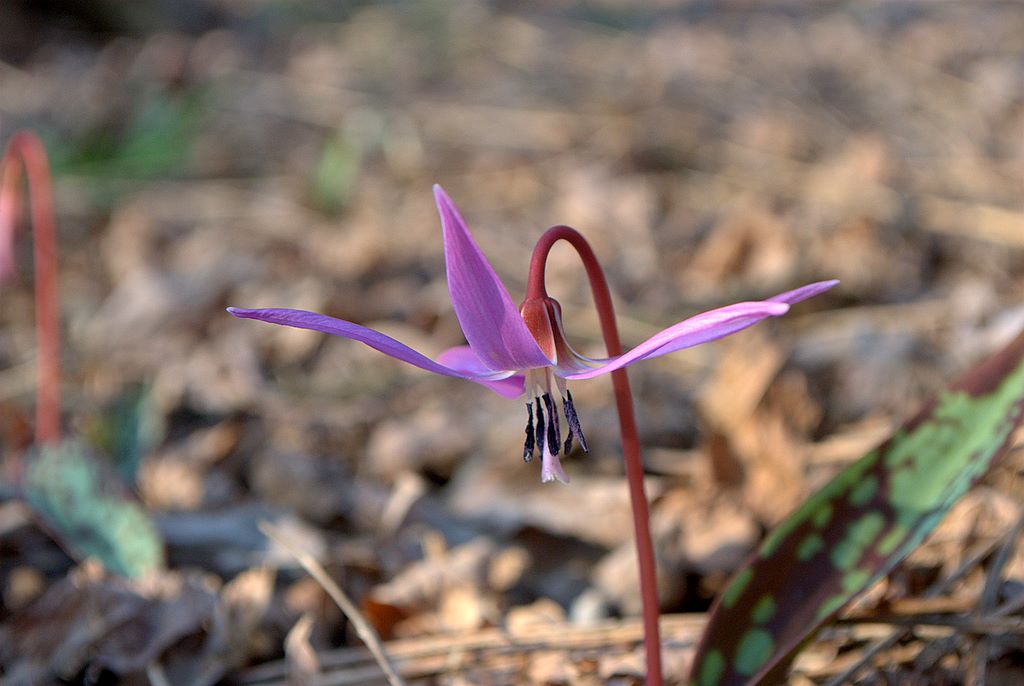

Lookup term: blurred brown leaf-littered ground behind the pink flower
[0,0,1024,683]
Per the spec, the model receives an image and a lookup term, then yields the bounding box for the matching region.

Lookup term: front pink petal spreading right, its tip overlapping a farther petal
[556,301,790,379]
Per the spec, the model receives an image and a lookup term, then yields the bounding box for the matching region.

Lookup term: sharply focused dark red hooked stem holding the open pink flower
[526,226,662,686]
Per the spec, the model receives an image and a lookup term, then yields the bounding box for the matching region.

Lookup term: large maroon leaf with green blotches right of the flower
[690,334,1024,686]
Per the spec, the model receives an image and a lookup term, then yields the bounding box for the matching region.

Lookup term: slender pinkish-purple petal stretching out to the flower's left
[227,307,521,387]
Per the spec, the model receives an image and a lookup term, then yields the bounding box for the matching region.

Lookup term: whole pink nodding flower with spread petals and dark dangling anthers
[227,185,838,483]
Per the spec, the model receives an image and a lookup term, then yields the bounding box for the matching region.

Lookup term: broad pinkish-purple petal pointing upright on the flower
[434,185,551,372]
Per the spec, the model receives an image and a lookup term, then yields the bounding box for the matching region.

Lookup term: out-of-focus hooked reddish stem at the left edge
[0,131,60,444]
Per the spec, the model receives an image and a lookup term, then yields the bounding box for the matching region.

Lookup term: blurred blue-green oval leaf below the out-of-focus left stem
[23,440,164,577]
